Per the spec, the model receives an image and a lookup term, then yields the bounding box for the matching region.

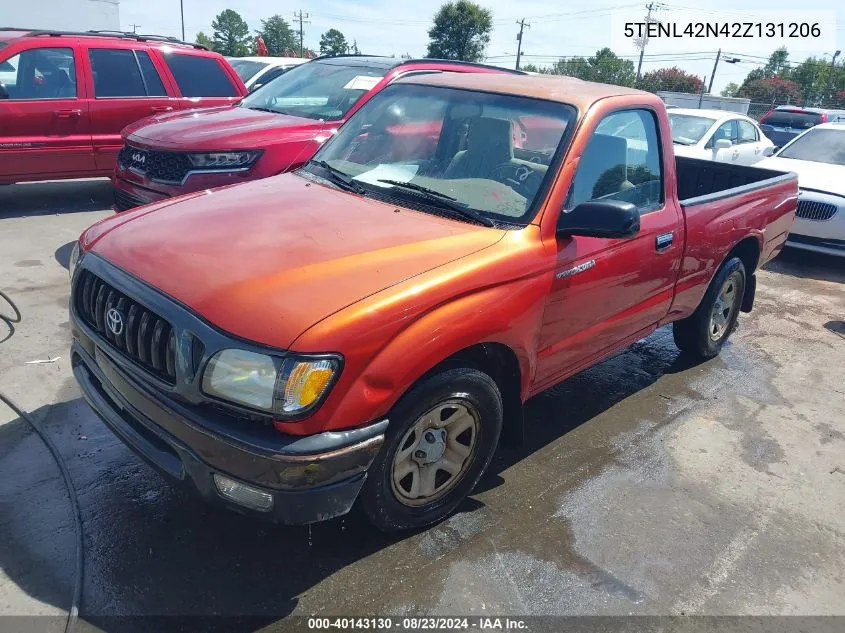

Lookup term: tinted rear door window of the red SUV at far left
[88,48,167,99]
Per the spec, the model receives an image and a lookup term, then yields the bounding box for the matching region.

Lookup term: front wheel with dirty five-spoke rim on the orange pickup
[361,367,503,532]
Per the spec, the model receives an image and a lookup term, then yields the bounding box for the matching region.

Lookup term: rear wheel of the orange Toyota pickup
[672,257,746,359]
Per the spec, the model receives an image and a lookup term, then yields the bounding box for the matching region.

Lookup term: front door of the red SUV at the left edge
[0,42,94,183]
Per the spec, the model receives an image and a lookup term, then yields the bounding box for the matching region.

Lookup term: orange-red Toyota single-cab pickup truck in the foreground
[70,73,798,531]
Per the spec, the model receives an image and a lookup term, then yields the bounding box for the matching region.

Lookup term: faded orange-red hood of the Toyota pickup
[83,174,504,352]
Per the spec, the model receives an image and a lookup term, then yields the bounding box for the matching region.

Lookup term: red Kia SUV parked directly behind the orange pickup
[112,55,516,211]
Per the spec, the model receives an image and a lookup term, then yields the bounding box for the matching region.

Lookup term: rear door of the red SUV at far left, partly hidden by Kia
[86,43,178,170]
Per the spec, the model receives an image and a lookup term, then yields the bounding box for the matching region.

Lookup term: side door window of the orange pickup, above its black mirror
[564,110,663,213]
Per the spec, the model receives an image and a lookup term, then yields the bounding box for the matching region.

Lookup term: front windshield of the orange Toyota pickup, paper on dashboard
[307,84,575,224]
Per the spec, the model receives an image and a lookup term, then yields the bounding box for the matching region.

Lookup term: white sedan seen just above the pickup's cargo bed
[667,108,775,165]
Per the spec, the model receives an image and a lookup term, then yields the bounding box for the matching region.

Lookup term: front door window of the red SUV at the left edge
[0,48,76,101]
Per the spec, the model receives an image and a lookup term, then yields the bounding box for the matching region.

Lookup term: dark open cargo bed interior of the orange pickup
[675,156,795,207]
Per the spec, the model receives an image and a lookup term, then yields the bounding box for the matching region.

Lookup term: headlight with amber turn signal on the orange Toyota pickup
[202,349,340,418]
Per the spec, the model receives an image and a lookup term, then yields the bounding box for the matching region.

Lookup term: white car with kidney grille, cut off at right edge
[755,123,845,257]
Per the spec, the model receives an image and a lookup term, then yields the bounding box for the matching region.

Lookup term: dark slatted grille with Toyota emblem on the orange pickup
[73,270,176,384]
